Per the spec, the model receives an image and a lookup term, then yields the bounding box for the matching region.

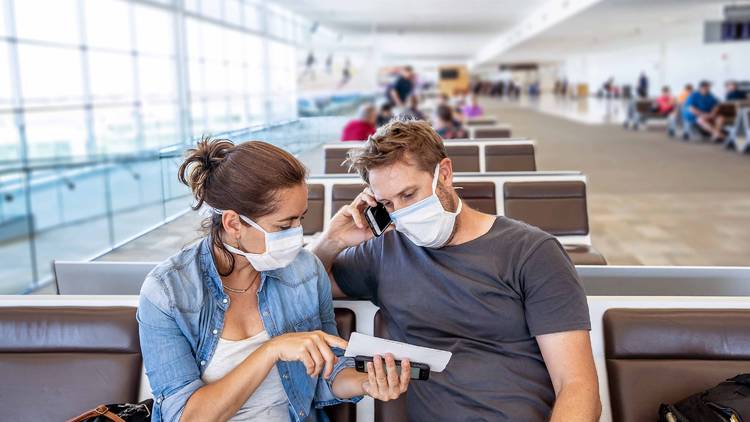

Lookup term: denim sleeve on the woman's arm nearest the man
[313,258,362,408]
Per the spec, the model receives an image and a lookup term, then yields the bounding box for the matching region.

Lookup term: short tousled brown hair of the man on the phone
[346,119,448,183]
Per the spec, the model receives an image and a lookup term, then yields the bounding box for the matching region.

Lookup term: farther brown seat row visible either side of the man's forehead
[323,139,536,174]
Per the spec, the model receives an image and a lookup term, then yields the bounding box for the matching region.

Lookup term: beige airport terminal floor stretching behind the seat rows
[88,98,750,266]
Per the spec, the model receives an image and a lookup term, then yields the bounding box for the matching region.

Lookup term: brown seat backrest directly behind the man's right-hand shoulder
[503,181,589,236]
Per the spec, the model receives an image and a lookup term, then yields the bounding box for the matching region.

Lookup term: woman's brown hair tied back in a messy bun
[178,138,307,276]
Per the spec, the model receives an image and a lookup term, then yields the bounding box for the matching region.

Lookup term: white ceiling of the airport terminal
[275,0,744,67]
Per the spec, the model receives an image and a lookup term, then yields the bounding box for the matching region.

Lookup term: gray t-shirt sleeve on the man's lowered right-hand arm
[520,238,591,336]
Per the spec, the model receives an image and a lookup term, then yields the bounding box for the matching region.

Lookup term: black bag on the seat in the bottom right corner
[659,374,750,422]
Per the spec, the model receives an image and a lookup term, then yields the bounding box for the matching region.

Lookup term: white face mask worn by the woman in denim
[224,215,303,271]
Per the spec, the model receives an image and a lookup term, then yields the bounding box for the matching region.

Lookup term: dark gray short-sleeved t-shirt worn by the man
[333,217,591,421]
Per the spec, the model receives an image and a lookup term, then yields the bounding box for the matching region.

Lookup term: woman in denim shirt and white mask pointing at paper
[137,140,410,422]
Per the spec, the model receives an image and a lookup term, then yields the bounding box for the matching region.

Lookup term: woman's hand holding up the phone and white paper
[362,353,411,401]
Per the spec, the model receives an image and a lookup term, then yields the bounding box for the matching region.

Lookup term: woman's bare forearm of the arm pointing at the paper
[180,344,276,422]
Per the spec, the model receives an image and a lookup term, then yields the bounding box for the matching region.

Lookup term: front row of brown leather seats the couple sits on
[0,296,750,422]
